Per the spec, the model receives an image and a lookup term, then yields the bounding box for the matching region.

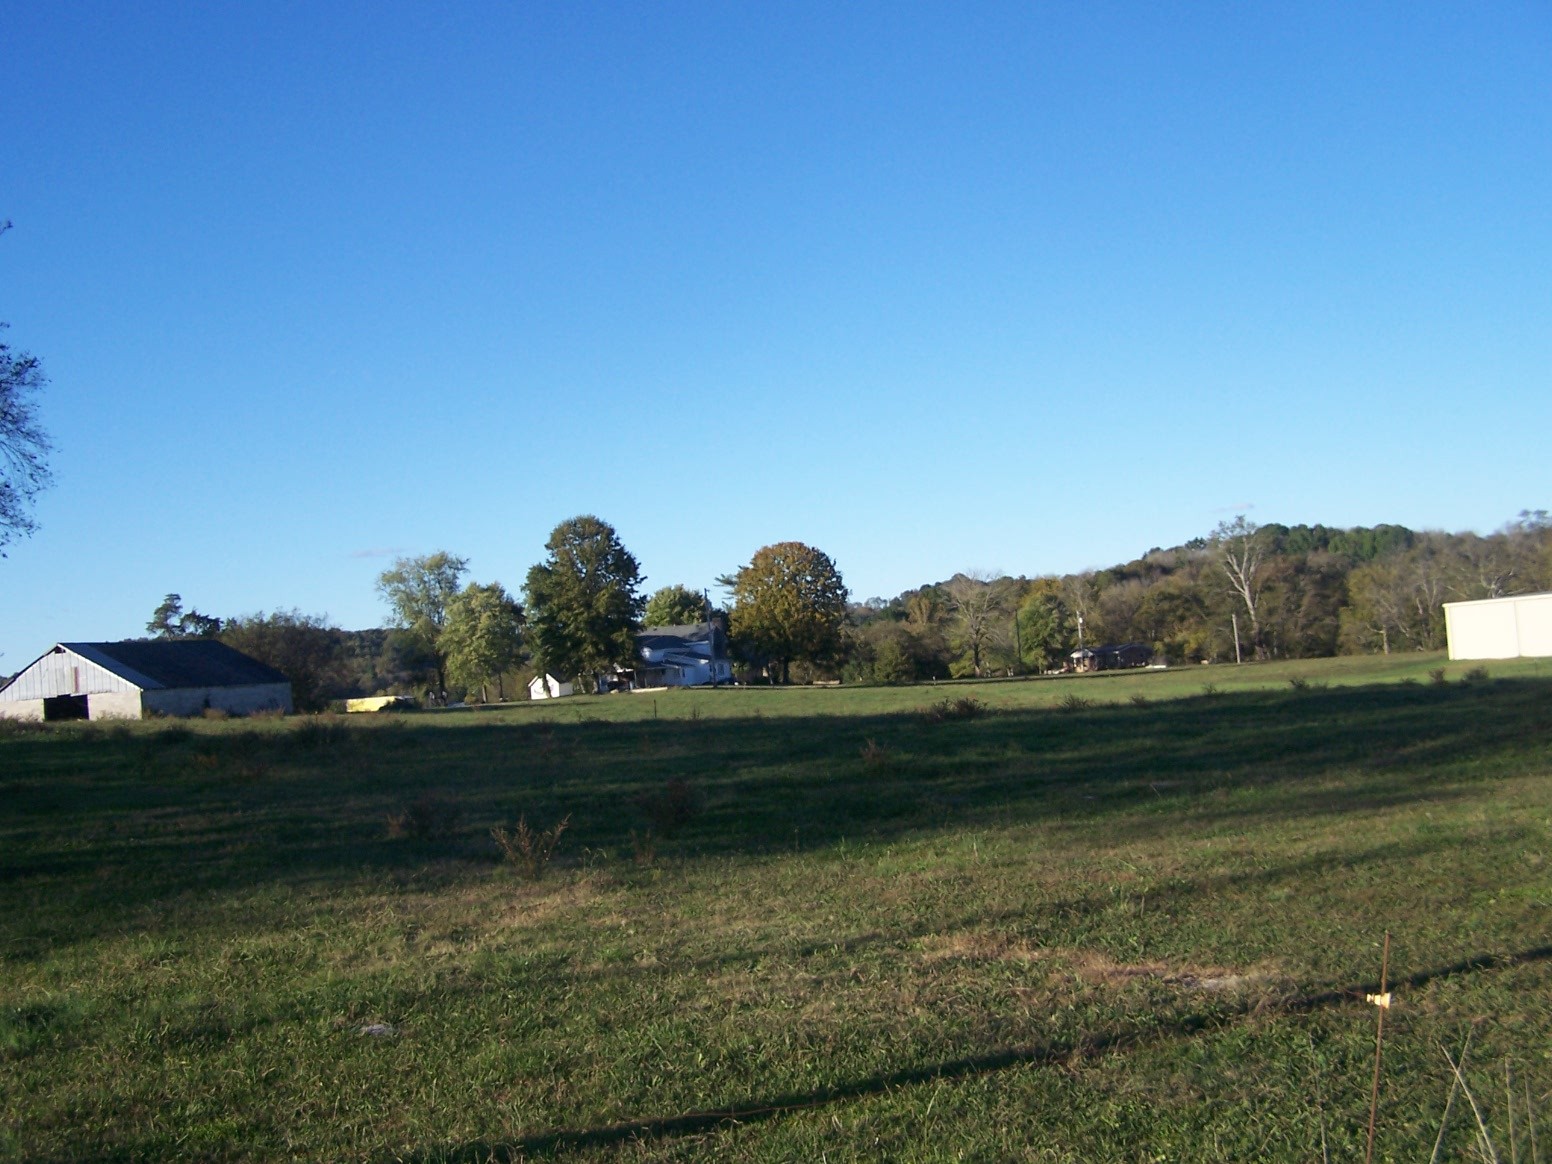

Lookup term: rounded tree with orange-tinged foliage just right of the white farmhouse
[731,542,847,683]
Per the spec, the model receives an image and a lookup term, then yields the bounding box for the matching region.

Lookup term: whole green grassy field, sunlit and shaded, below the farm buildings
[0,656,1552,1161]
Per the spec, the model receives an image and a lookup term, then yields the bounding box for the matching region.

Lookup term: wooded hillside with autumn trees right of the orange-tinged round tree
[844,511,1552,683]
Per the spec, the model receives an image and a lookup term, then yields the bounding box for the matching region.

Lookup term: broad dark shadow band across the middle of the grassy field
[0,680,1552,958]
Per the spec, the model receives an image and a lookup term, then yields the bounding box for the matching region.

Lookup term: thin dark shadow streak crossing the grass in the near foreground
[396,945,1552,1164]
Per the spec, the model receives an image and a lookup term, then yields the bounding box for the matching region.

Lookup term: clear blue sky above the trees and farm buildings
[0,0,1552,670]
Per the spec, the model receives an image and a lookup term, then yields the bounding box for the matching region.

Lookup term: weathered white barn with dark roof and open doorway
[0,638,292,720]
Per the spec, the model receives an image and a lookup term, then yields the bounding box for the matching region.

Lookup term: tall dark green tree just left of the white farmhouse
[523,514,644,691]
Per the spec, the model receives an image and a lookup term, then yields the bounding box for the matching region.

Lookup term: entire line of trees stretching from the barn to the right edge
[147,511,1552,708]
